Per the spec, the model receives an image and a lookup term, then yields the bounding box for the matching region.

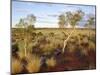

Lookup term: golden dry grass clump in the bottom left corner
[11,59,23,74]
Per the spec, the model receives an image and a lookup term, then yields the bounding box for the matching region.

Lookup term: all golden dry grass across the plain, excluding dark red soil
[12,29,95,73]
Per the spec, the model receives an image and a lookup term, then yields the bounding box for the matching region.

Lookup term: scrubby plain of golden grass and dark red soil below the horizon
[12,29,96,73]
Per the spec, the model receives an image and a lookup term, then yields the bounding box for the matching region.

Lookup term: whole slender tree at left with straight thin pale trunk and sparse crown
[16,14,36,56]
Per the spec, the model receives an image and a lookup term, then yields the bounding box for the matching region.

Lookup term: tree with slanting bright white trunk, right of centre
[62,10,84,53]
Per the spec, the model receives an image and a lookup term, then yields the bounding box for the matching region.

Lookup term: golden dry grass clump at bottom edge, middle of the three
[26,55,41,73]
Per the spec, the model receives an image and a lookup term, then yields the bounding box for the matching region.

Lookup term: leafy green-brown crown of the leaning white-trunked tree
[58,10,84,27]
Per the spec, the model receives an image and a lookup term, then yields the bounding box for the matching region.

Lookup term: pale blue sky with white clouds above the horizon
[12,0,95,28]
